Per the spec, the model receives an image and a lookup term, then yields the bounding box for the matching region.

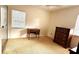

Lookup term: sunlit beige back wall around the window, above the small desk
[8,6,50,38]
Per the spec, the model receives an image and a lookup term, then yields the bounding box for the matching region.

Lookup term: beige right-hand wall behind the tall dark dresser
[48,6,79,38]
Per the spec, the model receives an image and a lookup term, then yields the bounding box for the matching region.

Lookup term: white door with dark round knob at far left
[0,6,8,39]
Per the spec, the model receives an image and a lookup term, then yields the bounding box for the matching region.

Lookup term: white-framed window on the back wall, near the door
[12,10,26,28]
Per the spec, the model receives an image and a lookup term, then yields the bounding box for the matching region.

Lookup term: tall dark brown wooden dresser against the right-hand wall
[54,27,70,48]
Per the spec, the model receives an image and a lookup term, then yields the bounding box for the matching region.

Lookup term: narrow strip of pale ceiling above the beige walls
[7,5,74,11]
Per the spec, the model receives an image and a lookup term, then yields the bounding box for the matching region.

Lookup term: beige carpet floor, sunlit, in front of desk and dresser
[4,37,69,54]
